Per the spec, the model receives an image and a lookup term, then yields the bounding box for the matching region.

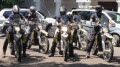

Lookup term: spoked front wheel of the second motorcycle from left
[39,36,49,54]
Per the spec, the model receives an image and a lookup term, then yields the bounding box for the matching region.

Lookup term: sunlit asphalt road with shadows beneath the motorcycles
[0,38,120,67]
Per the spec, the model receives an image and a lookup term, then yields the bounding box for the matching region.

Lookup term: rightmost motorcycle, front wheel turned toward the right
[92,23,114,62]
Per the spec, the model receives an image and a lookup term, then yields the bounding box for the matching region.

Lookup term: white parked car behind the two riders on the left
[0,8,55,37]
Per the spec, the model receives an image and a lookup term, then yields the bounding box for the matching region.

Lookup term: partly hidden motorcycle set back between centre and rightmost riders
[73,23,88,50]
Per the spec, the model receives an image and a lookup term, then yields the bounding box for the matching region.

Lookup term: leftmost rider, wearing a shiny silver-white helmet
[3,5,27,58]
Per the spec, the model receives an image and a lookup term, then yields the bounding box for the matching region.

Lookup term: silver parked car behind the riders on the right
[70,8,120,46]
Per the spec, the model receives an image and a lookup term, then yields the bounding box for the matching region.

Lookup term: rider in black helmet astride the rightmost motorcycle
[86,5,103,58]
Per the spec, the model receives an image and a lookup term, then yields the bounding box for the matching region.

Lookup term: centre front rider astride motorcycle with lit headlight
[49,7,73,57]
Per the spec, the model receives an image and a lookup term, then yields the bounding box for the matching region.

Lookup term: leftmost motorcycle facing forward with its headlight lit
[8,20,24,62]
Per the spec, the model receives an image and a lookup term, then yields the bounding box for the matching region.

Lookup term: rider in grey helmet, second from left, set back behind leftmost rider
[26,6,39,48]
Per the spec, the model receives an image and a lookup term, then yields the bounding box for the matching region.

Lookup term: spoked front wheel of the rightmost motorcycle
[103,41,114,62]
